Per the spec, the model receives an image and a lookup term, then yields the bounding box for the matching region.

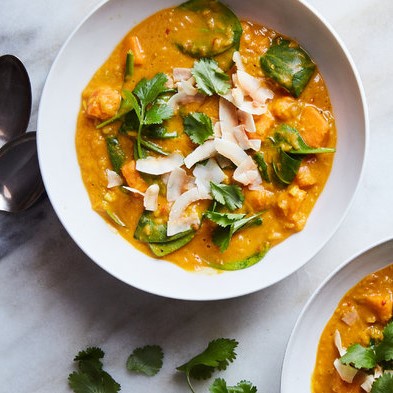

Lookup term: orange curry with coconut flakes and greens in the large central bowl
[76,0,336,270]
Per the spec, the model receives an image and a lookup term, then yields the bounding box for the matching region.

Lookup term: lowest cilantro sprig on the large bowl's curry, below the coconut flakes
[206,212,262,252]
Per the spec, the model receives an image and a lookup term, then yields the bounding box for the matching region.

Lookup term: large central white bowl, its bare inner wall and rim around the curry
[38,0,368,300]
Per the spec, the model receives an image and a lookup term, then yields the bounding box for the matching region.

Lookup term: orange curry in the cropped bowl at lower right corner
[311,265,393,393]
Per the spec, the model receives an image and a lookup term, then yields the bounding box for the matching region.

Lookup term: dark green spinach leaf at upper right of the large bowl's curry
[260,38,315,97]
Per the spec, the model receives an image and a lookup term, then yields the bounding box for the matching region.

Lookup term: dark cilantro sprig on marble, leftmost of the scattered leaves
[68,347,120,393]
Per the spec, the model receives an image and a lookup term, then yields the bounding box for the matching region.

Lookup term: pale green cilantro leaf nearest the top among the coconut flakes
[191,59,231,96]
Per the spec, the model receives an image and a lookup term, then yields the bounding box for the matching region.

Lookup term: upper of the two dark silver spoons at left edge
[0,55,31,147]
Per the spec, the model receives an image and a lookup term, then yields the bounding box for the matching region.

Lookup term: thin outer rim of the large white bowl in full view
[37,0,369,301]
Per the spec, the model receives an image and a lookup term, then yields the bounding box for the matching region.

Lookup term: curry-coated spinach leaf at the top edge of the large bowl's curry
[175,0,243,60]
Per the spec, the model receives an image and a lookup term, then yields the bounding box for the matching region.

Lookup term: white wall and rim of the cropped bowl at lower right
[281,240,393,393]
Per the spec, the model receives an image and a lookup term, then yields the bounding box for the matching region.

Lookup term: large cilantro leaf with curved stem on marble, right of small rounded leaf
[177,338,238,392]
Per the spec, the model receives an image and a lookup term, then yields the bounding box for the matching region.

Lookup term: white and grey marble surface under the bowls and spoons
[0,0,393,393]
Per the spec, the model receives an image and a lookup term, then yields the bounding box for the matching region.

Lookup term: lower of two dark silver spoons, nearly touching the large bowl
[0,132,44,213]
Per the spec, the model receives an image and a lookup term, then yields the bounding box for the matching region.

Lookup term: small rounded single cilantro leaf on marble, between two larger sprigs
[126,345,164,377]
